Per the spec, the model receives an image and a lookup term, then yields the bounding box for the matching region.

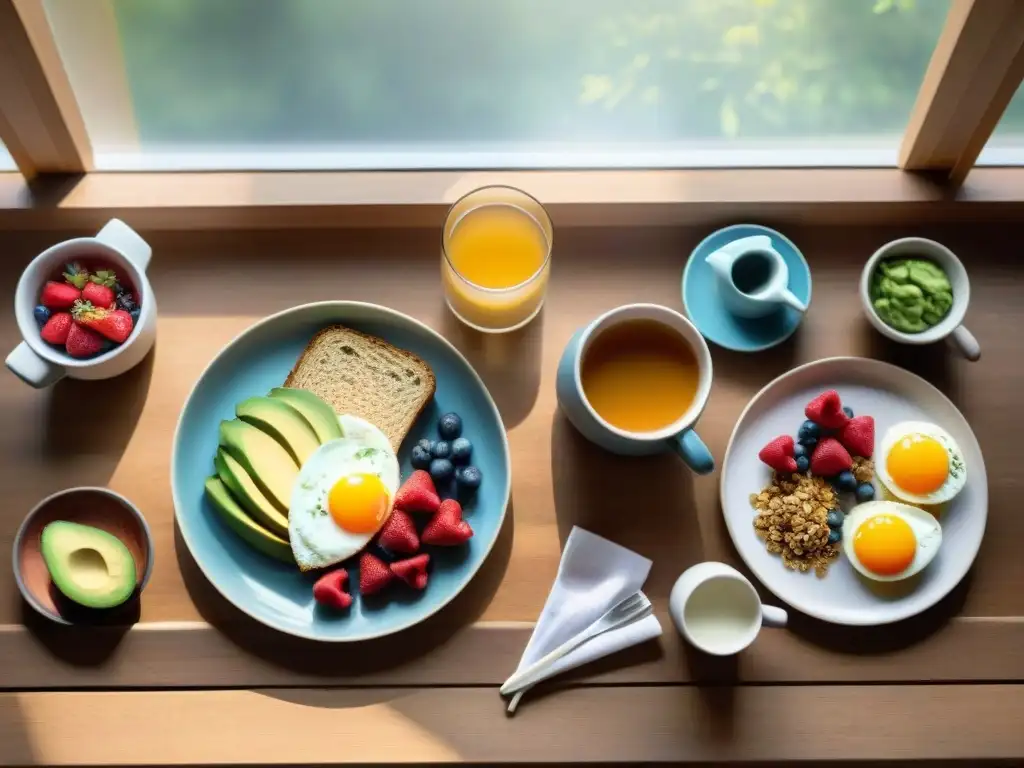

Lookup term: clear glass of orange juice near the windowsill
[441,186,552,333]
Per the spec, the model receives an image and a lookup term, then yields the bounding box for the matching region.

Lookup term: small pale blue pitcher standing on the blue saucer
[707,234,807,317]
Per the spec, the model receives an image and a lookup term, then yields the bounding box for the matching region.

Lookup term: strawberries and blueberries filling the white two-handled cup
[33,262,141,358]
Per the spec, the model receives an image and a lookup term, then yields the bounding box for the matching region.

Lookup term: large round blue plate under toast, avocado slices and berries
[171,301,520,642]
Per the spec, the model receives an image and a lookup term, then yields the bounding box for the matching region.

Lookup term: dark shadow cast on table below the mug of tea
[551,411,703,605]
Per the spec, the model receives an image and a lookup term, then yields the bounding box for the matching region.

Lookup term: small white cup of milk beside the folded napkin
[669,562,788,656]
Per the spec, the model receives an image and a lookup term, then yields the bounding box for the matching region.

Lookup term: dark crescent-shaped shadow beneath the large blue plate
[174,501,515,678]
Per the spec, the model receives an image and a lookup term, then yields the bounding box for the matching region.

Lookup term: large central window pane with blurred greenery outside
[46,0,949,169]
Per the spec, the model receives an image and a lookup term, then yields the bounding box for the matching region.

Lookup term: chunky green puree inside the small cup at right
[871,259,953,334]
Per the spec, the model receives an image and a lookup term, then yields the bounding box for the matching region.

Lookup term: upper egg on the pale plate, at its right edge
[874,421,967,504]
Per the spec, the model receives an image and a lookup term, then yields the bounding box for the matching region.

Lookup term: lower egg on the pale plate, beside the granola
[843,501,942,582]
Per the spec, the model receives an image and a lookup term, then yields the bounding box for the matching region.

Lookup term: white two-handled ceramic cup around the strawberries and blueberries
[6,219,157,388]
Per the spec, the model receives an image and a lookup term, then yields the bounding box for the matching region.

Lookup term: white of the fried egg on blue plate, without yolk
[288,414,399,570]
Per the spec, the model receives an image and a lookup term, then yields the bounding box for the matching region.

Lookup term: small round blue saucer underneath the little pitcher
[683,224,811,352]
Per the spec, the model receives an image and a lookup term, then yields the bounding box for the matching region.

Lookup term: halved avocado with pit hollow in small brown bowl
[40,520,135,608]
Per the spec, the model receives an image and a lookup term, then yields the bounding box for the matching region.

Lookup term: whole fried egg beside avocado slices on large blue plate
[288,414,398,570]
